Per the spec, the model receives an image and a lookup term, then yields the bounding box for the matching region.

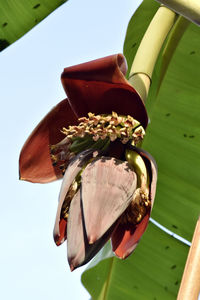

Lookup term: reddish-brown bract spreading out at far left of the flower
[19,99,77,183]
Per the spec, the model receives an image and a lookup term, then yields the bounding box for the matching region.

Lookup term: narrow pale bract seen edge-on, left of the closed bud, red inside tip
[53,150,93,246]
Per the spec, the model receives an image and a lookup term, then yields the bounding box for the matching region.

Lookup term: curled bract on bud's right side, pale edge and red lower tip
[111,147,157,258]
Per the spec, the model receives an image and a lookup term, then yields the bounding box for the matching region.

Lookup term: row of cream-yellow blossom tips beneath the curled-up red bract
[62,112,145,144]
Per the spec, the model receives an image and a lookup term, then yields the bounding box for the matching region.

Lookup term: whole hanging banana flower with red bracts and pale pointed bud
[19,54,157,270]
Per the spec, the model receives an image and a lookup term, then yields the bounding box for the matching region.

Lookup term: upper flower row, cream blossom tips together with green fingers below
[50,112,145,173]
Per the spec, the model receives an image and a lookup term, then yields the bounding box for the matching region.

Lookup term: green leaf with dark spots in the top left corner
[0,0,67,51]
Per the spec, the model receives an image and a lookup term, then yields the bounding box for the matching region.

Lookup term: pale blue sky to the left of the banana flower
[0,0,141,300]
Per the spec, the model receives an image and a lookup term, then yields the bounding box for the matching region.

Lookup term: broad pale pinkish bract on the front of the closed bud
[81,157,137,244]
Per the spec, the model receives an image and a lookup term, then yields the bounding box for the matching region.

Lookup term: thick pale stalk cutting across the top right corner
[157,0,200,25]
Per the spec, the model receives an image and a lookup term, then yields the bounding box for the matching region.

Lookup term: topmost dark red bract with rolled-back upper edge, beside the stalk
[61,54,148,127]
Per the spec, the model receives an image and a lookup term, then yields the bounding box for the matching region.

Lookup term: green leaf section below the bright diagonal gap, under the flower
[82,224,189,300]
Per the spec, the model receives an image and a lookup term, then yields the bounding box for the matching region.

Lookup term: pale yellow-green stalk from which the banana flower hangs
[129,6,176,101]
